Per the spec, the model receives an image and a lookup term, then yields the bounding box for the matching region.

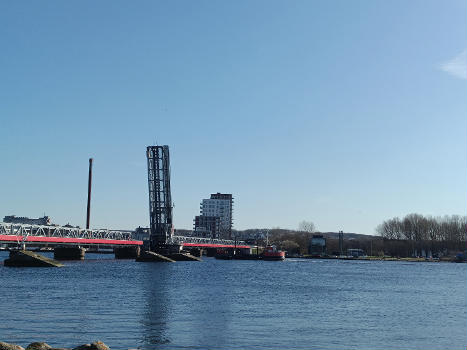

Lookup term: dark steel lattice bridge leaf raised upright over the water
[147,146,173,251]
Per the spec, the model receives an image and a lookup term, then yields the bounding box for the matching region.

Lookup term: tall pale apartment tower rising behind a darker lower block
[200,192,233,239]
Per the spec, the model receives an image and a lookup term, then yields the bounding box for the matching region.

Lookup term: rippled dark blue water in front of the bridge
[0,252,467,349]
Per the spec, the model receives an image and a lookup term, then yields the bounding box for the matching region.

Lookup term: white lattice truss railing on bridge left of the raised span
[0,222,133,240]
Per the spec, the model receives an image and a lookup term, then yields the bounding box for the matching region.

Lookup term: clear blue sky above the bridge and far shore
[0,0,467,234]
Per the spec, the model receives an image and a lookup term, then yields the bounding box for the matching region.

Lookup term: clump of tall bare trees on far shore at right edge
[376,214,467,256]
